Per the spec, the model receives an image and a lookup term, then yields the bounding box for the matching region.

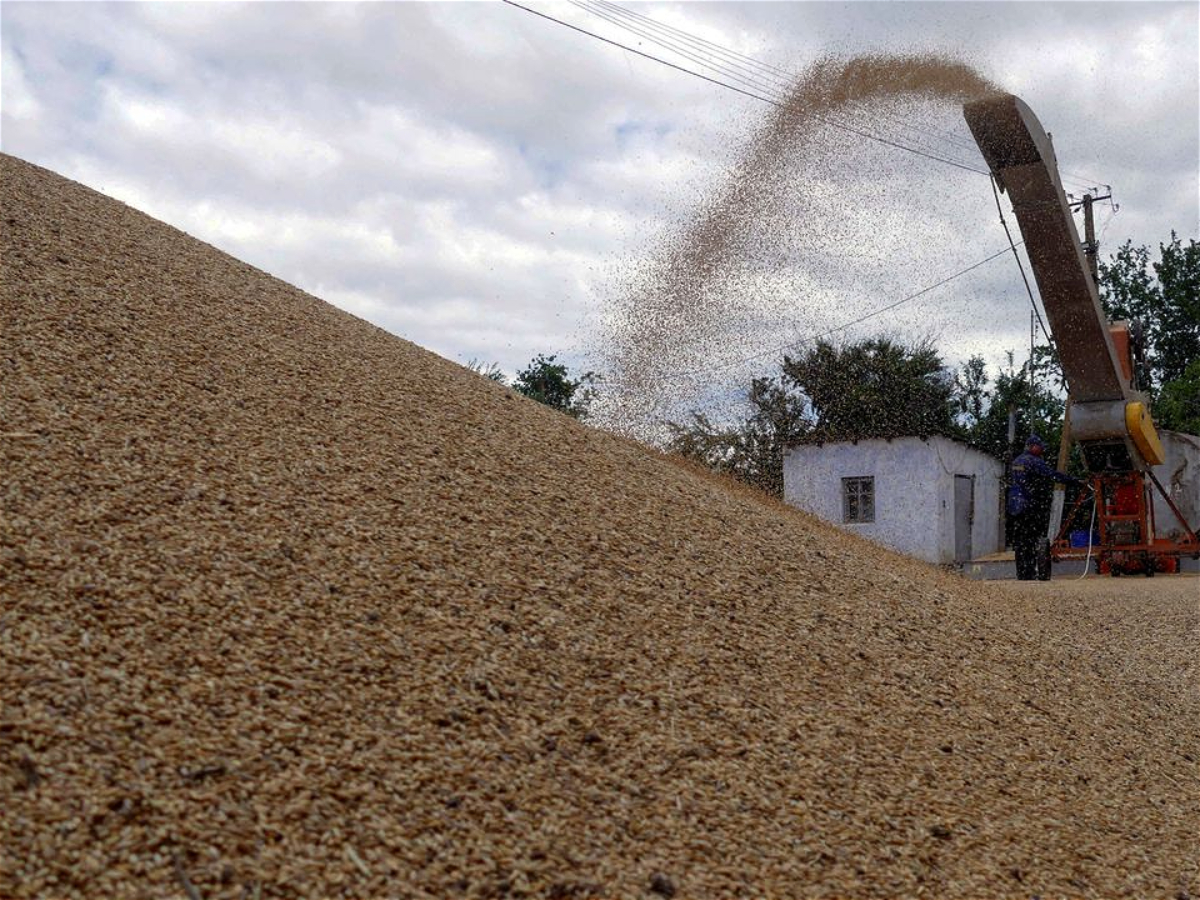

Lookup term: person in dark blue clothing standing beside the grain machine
[1007,434,1082,581]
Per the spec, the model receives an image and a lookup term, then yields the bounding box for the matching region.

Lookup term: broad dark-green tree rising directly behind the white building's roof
[784,337,955,440]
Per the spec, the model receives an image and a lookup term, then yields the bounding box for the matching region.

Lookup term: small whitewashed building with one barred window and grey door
[784,437,1004,564]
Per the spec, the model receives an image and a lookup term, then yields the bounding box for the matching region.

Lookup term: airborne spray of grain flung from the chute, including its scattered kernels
[599,54,1000,439]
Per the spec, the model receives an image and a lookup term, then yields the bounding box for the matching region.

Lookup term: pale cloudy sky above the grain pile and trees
[0,0,1200,424]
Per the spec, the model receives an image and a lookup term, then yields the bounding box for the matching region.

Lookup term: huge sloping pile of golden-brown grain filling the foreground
[0,157,1200,900]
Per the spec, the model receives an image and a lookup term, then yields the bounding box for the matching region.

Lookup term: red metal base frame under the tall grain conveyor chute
[1050,472,1200,575]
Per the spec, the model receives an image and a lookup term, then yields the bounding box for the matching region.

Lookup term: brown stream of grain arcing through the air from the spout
[601,55,1000,436]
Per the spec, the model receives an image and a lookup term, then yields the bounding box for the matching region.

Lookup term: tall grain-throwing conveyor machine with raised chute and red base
[962,94,1200,575]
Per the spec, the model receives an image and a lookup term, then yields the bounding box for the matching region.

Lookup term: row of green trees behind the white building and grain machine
[668,233,1200,496]
